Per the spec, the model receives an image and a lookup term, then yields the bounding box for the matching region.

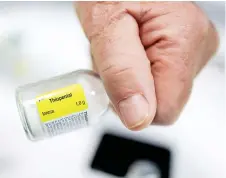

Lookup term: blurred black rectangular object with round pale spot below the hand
[91,133,171,178]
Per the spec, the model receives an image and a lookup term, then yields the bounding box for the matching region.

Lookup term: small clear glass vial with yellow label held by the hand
[16,70,109,141]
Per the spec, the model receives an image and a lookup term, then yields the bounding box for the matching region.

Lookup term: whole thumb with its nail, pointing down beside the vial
[77,3,156,130]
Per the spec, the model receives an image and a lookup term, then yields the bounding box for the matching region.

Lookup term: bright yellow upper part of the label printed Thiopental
[36,84,88,122]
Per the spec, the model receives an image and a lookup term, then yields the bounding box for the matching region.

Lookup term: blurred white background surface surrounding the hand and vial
[0,2,226,178]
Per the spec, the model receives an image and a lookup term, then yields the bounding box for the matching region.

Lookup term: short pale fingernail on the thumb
[119,94,149,129]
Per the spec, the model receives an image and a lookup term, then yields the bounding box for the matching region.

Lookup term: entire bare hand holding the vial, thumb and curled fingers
[75,2,218,130]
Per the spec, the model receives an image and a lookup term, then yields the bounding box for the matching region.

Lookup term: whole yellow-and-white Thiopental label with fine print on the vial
[36,84,88,136]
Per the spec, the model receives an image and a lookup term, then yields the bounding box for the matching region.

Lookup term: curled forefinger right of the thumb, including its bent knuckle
[141,4,217,125]
